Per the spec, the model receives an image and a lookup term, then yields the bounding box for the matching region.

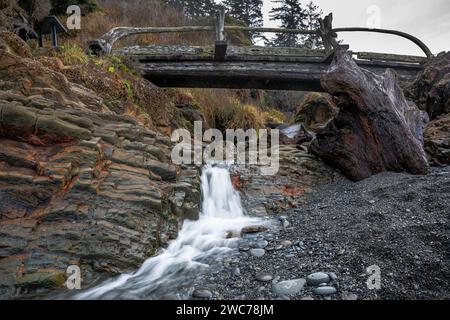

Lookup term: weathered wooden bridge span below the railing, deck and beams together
[115,45,422,91]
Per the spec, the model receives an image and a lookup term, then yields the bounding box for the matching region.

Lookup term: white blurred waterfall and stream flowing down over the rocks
[75,166,262,299]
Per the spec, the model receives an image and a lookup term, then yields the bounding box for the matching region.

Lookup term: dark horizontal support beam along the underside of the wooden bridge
[137,60,421,91]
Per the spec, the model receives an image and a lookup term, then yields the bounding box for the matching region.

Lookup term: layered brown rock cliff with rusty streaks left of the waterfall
[0,33,200,298]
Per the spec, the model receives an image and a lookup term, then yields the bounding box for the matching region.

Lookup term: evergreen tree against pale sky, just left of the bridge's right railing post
[267,0,322,48]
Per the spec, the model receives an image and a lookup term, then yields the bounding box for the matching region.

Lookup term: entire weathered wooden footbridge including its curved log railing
[89,10,432,91]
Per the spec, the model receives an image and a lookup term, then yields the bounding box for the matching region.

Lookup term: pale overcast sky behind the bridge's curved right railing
[255,0,450,55]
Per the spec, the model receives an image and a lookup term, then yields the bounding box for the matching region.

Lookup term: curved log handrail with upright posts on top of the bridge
[89,9,432,63]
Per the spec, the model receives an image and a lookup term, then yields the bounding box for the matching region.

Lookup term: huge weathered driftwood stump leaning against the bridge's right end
[311,50,428,181]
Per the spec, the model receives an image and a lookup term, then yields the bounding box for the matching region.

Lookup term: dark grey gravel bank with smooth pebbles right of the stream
[193,167,450,300]
